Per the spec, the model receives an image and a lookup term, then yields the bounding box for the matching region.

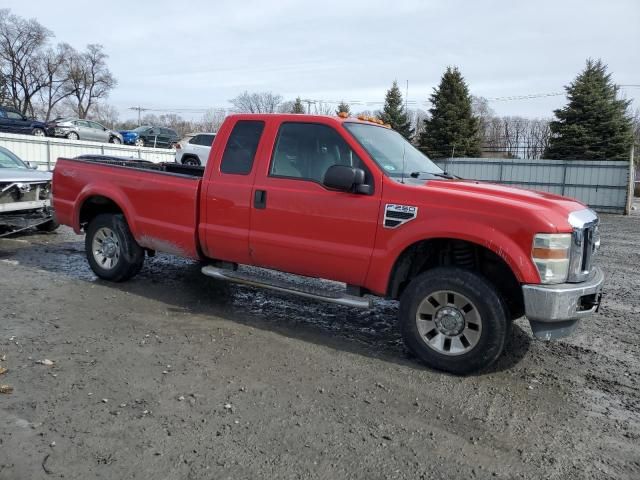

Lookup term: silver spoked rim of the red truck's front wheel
[416,290,482,356]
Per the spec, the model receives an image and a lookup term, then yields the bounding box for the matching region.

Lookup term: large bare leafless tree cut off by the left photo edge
[0,9,53,115]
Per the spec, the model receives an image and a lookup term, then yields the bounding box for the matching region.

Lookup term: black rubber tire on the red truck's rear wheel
[84,213,144,282]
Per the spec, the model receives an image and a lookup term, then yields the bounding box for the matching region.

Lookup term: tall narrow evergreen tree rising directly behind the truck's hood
[419,67,480,158]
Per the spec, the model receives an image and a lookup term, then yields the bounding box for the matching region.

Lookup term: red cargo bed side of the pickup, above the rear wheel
[53,155,204,258]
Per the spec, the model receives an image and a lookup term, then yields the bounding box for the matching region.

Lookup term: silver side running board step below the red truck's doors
[202,265,372,309]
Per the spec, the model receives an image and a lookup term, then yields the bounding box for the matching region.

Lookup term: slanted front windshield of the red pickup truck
[343,122,443,177]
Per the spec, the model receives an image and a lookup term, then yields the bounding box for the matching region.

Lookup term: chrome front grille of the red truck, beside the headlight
[568,209,600,282]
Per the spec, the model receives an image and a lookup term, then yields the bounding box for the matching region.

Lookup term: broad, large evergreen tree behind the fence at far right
[544,59,633,160]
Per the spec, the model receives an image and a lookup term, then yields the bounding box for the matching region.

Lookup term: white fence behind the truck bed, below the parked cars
[0,133,175,170]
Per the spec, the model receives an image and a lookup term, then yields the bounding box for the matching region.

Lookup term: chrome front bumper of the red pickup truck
[522,267,604,340]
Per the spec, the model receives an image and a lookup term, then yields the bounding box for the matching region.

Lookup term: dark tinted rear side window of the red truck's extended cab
[220,120,264,175]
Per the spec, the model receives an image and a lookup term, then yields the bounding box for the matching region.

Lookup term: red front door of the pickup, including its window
[249,121,381,285]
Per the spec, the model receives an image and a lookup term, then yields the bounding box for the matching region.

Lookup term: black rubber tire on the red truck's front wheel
[399,267,510,375]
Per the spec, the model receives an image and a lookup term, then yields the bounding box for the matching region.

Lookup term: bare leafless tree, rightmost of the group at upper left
[69,44,117,118]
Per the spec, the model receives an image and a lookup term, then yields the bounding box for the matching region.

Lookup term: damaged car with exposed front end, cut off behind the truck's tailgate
[0,147,58,237]
